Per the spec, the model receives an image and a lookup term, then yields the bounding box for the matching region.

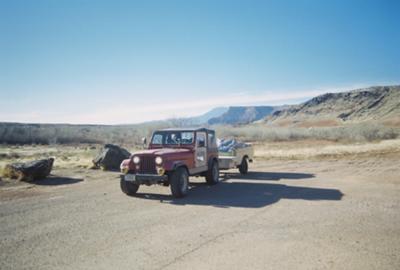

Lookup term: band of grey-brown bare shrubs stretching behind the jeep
[0,120,400,146]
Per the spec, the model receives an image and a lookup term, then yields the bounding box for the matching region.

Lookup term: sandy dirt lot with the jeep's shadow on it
[0,153,400,270]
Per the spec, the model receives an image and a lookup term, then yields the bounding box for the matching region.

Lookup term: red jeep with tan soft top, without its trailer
[121,128,219,198]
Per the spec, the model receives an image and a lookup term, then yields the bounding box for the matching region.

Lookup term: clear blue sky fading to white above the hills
[0,0,400,124]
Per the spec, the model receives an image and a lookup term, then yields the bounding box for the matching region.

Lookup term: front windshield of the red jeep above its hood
[151,131,194,145]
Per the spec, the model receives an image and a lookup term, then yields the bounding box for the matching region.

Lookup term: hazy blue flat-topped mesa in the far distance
[208,106,275,125]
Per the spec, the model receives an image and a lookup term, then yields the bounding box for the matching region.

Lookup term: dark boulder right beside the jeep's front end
[93,144,131,171]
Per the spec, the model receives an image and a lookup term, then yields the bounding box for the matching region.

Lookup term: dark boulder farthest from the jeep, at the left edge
[3,158,54,182]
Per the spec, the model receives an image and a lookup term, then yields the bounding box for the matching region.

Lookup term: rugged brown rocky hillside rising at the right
[265,85,400,123]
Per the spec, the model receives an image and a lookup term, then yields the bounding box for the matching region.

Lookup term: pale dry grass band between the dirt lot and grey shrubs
[0,139,400,175]
